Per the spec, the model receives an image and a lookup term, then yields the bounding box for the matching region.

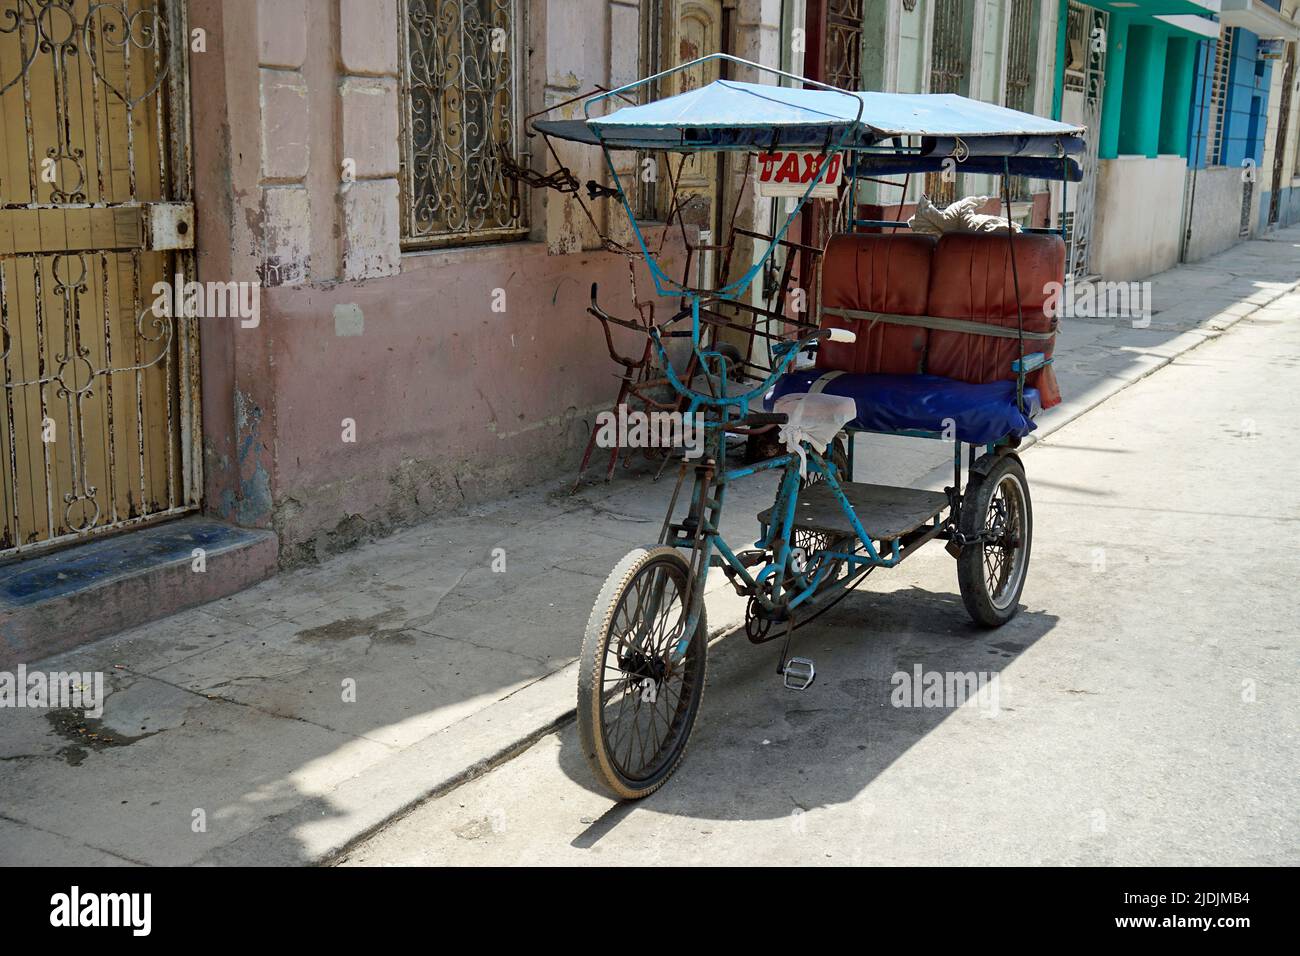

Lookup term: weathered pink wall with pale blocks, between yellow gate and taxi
[187,0,681,563]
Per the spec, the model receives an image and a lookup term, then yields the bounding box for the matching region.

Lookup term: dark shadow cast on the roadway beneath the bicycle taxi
[560,588,1058,832]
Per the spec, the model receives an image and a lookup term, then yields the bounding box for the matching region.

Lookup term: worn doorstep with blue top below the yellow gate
[0,515,278,669]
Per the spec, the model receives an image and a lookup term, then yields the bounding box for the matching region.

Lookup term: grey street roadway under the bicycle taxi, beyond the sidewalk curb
[346,278,1300,865]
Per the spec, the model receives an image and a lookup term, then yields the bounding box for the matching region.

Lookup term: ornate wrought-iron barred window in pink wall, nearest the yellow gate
[399,0,528,248]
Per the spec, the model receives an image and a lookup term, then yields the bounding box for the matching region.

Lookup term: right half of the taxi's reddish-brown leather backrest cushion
[926,233,1065,408]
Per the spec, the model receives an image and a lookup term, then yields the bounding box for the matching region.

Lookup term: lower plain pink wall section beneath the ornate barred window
[264,235,680,561]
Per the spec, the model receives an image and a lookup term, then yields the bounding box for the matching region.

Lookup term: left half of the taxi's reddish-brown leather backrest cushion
[816,233,936,375]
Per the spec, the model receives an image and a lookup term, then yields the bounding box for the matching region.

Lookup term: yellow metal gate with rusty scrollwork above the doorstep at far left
[0,0,202,555]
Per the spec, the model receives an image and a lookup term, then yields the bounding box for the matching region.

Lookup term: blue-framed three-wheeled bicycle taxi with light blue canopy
[534,55,1084,799]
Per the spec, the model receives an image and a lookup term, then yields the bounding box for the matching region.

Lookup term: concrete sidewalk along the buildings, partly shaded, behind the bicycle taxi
[0,229,1300,864]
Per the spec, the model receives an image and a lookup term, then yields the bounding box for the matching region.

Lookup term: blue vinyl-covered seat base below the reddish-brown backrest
[763,368,1043,445]
